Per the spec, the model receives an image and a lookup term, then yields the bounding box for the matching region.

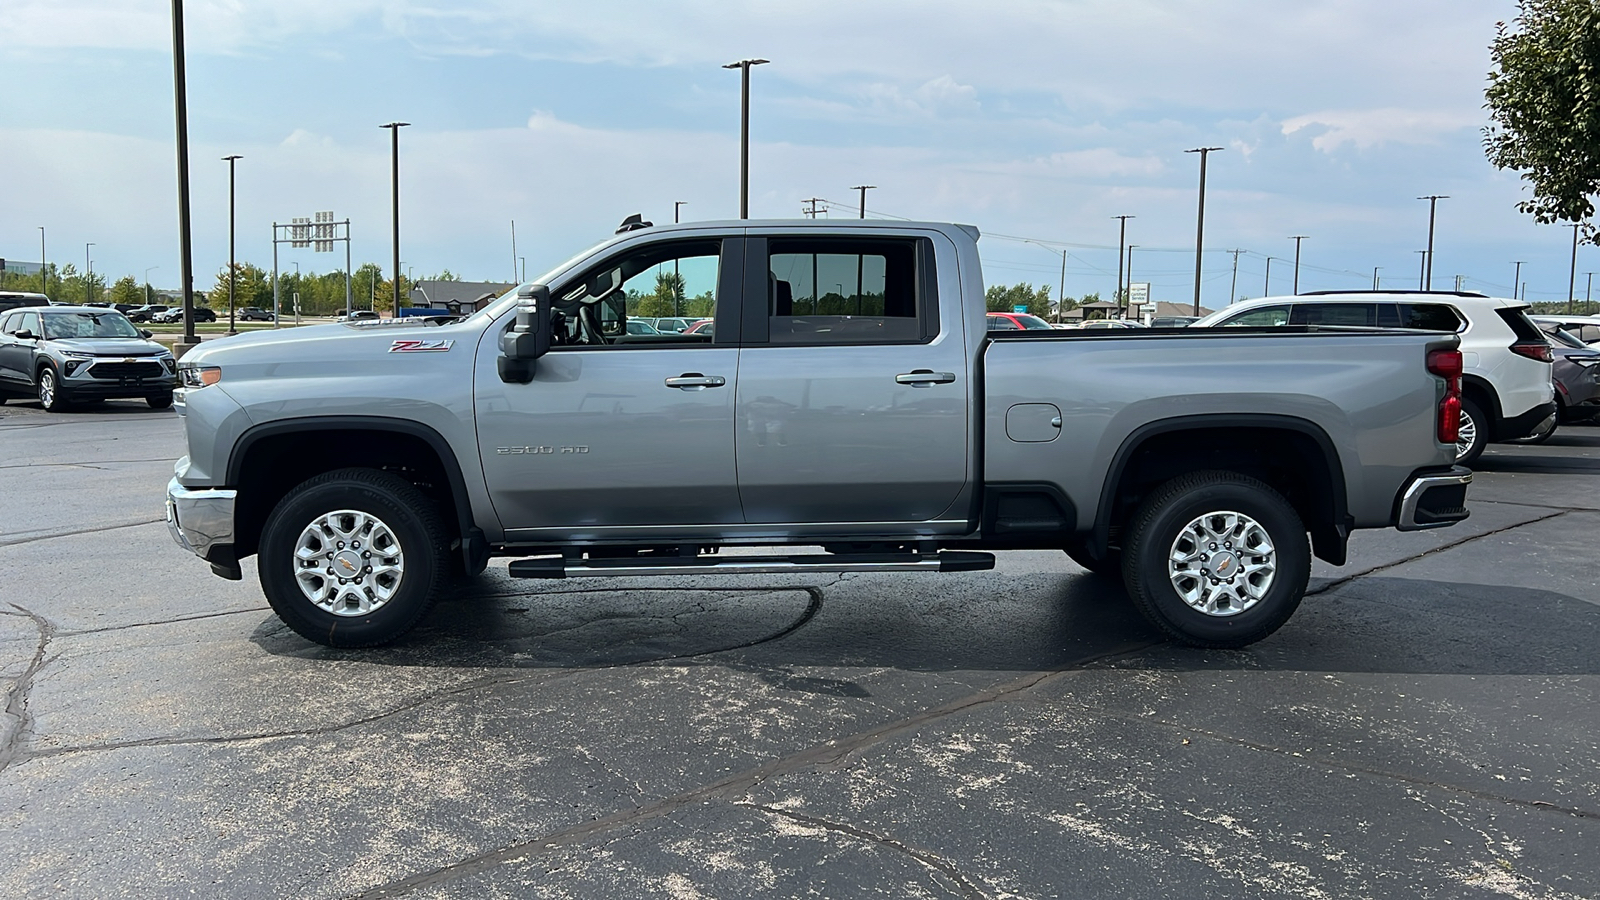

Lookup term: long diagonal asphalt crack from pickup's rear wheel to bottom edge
[350,641,1160,900]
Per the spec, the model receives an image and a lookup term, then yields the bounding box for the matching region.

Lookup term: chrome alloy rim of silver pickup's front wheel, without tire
[294,509,405,617]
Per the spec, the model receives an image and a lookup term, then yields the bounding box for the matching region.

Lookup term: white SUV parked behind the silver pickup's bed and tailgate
[1190,290,1555,466]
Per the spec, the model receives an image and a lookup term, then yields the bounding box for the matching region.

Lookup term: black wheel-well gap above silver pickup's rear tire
[1088,413,1354,565]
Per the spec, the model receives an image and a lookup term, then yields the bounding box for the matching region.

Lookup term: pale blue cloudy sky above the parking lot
[0,0,1574,306]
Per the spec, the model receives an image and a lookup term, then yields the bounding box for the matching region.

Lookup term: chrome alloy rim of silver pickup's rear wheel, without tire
[1166,511,1278,618]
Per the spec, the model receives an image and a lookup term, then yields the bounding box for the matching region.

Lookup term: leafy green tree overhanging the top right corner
[1483,0,1600,242]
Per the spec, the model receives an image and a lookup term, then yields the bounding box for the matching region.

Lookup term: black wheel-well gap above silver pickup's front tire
[226,416,488,573]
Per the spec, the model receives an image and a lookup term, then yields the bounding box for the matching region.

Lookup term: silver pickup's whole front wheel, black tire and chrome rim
[258,469,450,647]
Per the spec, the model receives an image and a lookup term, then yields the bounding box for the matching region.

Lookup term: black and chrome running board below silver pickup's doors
[510,549,995,578]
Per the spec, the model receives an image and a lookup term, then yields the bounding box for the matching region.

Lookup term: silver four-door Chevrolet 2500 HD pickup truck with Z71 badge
[166,221,1472,647]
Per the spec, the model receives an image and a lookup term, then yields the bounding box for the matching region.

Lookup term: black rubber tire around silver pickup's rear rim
[1122,471,1310,647]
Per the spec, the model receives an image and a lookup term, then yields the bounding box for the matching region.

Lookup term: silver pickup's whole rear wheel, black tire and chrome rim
[1122,471,1310,647]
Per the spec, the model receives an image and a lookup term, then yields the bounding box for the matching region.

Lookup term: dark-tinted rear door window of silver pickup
[766,239,938,344]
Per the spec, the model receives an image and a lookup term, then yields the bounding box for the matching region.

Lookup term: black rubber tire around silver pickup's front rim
[256,469,450,647]
